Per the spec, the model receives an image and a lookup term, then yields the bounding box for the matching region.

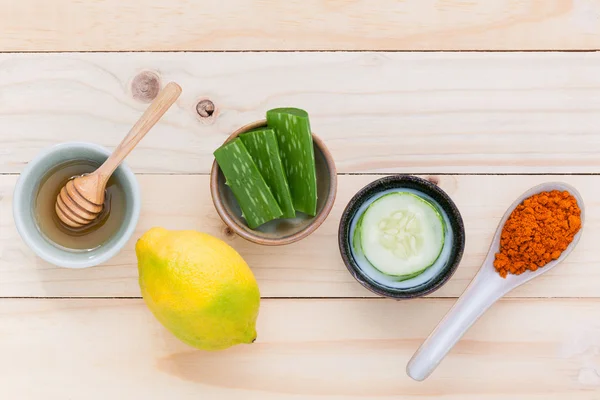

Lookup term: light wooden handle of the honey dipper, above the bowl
[96,82,181,180]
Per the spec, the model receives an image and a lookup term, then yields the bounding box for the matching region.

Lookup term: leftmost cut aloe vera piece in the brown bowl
[214,139,283,229]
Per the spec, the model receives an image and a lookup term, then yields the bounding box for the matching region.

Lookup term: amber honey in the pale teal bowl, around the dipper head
[34,160,126,251]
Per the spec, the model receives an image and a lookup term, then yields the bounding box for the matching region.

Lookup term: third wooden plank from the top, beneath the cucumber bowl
[0,175,600,297]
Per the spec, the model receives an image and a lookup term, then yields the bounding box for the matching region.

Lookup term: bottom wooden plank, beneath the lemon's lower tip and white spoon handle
[0,299,600,400]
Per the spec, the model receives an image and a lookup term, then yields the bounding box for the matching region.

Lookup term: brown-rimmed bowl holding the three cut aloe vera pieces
[210,120,337,246]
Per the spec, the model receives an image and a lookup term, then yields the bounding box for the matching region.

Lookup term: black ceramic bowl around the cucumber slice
[338,175,465,299]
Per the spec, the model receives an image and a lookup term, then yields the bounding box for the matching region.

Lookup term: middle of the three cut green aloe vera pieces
[240,128,296,218]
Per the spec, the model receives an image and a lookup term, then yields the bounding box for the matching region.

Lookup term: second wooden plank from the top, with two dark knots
[0,52,600,173]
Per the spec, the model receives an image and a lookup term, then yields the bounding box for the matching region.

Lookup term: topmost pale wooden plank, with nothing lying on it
[0,0,600,51]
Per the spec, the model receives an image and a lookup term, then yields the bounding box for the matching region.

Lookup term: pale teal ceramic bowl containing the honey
[13,142,141,268]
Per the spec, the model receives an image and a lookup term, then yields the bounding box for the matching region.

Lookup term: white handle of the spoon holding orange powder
[406,257,506,381]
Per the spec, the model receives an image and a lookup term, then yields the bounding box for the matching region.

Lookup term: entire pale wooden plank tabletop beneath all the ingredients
[0,0,600,400]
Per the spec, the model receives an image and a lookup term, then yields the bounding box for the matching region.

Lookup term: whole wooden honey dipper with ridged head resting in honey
[55,82,181,229]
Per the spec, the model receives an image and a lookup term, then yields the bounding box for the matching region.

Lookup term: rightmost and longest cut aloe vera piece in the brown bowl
[267,108,317,216]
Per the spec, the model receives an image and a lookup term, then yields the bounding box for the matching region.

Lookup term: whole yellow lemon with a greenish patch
[135,228,260,350]
